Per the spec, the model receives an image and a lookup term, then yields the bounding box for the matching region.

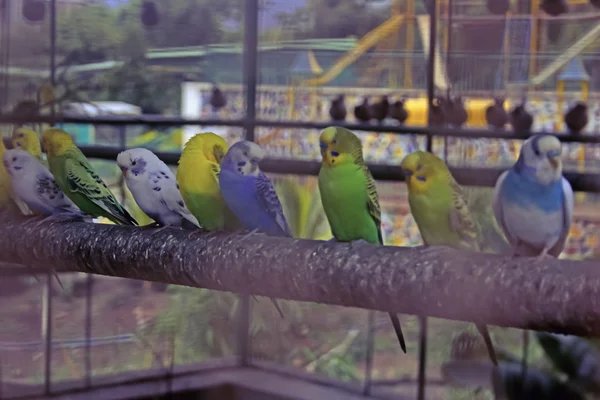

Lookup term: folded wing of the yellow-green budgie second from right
[449,177,479,251]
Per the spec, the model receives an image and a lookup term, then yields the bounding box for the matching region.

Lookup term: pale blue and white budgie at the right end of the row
[493,135,574,260]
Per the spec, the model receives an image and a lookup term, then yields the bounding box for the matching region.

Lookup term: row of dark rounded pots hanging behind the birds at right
[329,92,589,134]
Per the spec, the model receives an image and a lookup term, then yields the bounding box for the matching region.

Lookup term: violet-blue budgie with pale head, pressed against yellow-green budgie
[219,141,292,317]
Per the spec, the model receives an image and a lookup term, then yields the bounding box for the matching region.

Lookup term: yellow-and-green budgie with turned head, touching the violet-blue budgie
[177,132,236,231]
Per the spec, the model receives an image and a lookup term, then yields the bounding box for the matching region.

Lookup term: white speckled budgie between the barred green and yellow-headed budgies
[117,148,200,228]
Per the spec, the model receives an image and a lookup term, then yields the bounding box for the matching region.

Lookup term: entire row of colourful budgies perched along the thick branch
[0,126,574,364]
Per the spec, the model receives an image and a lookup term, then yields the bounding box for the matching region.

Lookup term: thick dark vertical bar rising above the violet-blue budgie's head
[244,0,258,142]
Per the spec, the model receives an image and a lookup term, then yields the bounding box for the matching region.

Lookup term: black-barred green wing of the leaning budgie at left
[65,157,137,225]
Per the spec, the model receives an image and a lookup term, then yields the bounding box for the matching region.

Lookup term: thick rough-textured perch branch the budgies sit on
[0,215,600,335]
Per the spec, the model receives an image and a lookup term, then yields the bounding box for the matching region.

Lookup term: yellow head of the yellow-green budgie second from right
[400,150,450,193]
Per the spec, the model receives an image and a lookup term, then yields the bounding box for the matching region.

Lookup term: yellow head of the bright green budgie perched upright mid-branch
[319,126,364,167]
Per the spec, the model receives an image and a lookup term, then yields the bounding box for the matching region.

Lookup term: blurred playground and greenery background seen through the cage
[0,0,600,400]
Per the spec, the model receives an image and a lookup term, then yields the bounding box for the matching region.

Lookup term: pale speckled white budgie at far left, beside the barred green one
[2,149,83,217]
